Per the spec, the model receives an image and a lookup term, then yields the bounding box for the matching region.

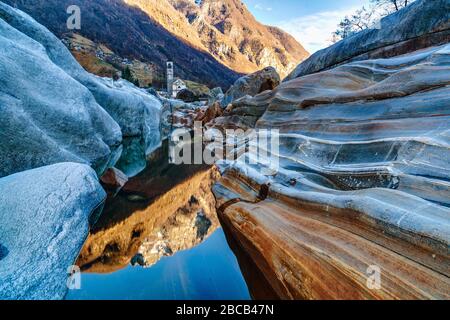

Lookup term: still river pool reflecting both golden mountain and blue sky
[66,142,250,300]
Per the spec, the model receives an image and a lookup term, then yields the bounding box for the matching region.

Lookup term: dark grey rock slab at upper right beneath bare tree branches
[284,0,450,82]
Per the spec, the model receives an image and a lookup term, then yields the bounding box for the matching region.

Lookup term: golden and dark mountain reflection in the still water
[78,142,219,273]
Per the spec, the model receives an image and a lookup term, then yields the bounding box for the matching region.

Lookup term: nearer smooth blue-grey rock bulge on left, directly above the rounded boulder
[0,15,122,177]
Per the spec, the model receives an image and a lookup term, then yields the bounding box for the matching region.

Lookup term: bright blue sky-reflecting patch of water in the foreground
[66,228,250,300]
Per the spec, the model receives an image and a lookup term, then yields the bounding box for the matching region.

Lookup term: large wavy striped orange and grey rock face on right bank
[214,41,450,299]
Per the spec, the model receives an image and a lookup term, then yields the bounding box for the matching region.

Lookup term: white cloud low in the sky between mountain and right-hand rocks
[277,7,360,54]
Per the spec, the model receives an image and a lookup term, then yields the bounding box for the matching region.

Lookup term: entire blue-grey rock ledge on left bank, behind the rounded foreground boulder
[0,2,161,176]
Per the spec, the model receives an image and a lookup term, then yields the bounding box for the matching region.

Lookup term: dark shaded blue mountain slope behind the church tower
[5,0,239,88]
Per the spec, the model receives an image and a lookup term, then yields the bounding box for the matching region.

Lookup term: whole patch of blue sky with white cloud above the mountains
[243,0,370,53]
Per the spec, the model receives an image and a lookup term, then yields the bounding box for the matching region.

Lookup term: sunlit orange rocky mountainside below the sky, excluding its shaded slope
[163,0,309,77]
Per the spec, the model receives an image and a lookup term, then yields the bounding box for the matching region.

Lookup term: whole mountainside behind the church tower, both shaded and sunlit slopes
[5,0,308,89]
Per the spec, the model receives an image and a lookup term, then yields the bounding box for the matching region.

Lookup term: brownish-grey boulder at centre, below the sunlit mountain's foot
[220,67,280,108]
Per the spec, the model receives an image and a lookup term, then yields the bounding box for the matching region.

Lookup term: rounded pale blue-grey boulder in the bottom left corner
[0,163,106,300]
